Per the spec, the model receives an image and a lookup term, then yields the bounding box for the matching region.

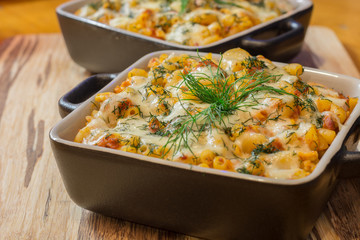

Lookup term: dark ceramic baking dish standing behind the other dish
[56,0,313,73]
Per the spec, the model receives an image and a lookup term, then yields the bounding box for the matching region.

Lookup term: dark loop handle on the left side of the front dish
[58,73,117,118]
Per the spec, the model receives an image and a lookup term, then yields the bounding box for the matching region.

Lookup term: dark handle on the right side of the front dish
[339,117,360,178]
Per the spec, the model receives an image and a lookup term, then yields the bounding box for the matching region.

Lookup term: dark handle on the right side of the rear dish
[240,18,306,61]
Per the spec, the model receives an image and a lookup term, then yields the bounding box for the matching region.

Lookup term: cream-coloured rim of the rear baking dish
[56,0,313,51]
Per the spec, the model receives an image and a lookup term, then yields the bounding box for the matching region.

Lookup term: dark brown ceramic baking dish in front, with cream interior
[50,51,360,240]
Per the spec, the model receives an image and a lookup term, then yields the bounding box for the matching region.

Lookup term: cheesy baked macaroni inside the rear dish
[75,0,292,46]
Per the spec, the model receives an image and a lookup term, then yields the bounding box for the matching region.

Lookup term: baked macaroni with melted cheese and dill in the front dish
[75,48,358,179]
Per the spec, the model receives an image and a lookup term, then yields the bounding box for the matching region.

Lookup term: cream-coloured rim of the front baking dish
[49,50,360,185]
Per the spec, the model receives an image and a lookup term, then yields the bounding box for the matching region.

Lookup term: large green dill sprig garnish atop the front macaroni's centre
[164,56,296,156]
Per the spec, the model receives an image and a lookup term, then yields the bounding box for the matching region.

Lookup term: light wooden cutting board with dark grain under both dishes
[0,27,360,239]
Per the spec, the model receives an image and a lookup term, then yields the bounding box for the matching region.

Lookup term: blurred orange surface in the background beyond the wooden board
[0,0,360,69]
